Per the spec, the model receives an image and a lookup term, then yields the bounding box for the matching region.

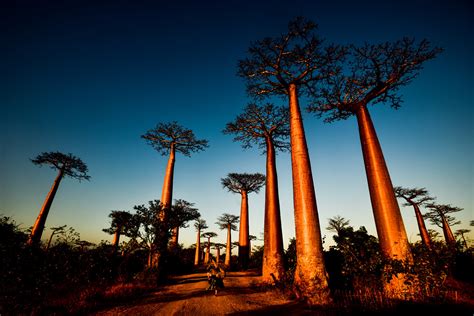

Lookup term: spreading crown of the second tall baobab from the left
[141,121,209,157]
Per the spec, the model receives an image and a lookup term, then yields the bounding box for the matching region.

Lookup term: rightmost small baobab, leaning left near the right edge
[424,203,463,247]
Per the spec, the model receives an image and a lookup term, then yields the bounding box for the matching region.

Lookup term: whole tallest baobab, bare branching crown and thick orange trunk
[238,18,344,305]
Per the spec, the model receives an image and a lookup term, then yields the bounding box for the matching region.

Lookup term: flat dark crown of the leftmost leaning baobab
[31,151,90,181]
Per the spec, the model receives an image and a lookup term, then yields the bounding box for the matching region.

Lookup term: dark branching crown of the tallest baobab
[238,17,345,96]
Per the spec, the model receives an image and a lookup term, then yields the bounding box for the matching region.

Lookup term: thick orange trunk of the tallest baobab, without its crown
[288,84,331,305]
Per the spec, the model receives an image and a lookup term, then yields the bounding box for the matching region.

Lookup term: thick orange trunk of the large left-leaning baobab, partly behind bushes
[356,104,412,296]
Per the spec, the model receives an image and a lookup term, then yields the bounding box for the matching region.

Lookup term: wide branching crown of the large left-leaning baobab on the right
[308,38,442,122]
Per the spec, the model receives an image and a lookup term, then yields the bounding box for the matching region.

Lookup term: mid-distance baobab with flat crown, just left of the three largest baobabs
[221,173,265,269]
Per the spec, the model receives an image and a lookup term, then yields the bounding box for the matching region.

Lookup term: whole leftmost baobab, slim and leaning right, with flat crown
[28,151,90,246]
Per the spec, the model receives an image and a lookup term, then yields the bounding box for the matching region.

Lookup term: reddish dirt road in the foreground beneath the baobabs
[96,272,306,315]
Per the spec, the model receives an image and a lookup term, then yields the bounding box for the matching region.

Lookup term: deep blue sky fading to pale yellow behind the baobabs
[0,0,474,249]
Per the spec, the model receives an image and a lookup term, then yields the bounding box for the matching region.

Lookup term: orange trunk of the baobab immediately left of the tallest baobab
[262,138,284,283]
